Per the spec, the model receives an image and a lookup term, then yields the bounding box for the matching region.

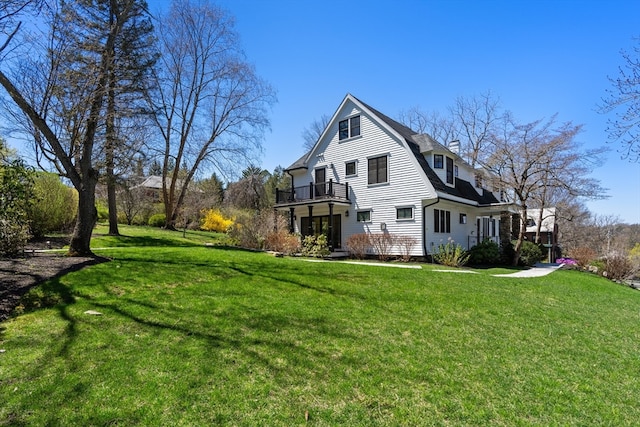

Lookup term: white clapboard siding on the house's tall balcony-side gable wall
[295,101,435,256]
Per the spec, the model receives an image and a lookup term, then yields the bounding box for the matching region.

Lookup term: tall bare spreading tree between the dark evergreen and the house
[150,0,275,228]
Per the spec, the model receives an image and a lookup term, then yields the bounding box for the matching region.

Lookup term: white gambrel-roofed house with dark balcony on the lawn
[276,94,511,256]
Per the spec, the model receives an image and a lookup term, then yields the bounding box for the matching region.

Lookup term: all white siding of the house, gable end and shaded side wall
[282,96,508,256]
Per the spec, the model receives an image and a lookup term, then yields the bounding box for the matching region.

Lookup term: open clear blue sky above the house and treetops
[181,0,640,223]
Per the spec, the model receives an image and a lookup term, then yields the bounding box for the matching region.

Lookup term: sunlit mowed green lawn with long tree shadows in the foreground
[0,229,640,426]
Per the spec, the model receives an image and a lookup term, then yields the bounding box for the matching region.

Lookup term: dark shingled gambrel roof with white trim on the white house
[285,94,500,205]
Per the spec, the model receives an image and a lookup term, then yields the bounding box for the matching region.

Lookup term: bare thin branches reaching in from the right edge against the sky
[600,37,640,162]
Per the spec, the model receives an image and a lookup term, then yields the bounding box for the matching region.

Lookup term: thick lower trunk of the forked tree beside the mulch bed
[68,174,98,256]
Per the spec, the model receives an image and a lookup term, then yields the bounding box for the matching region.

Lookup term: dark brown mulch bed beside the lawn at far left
[0,238,108,322]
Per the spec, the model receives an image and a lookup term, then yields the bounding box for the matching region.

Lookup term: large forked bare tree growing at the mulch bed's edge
[0,0,141,255]
